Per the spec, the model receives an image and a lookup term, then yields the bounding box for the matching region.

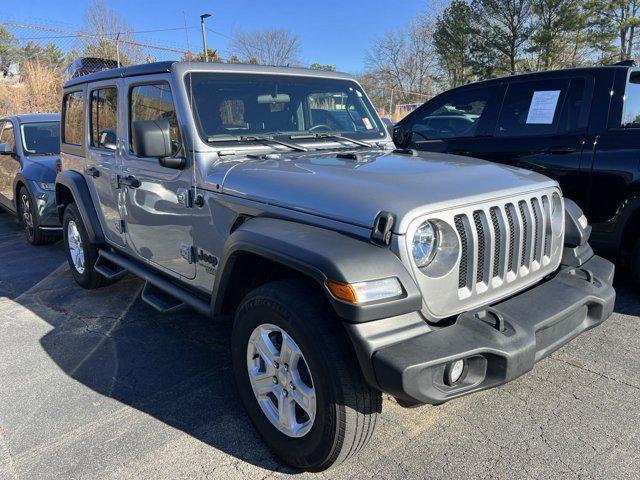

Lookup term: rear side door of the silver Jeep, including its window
[84,80,125,246]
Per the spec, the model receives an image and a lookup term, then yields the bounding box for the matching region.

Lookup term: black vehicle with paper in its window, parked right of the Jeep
[394,65,640,281]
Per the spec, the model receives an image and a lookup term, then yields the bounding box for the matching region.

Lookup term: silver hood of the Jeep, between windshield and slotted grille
[222,150,557,234]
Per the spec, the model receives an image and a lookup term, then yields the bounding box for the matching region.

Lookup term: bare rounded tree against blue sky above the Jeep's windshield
[231,29,301,66]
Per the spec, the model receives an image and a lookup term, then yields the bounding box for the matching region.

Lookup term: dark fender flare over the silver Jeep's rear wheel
[56,170,104,244]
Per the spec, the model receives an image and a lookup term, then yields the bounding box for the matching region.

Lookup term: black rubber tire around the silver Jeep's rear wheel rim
[62,203,111,290]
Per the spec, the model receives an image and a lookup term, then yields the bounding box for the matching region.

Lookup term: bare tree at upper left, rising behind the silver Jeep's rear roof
[80,0,145,65]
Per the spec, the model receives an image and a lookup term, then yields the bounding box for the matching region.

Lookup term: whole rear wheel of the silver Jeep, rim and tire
[62,203,110,290]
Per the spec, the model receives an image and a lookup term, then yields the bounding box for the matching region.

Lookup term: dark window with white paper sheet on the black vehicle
[496,79,569,137]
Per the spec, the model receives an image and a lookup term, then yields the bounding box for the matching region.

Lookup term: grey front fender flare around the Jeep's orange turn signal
[212,218,422,322]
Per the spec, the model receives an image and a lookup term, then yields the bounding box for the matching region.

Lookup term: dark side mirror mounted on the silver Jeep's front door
[131,120,185,170]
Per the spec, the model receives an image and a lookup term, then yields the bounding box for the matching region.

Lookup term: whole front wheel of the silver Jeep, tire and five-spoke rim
[231,281,382,471]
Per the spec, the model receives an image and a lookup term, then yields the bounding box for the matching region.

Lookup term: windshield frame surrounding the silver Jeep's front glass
[183,70,388,148]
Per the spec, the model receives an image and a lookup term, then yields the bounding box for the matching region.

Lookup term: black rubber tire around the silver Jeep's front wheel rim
[231,280,382,471]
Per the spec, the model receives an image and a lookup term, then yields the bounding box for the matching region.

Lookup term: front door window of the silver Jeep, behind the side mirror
[129,83,182,156]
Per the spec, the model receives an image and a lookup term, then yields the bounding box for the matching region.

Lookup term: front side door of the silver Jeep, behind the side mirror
[121,76,196,278]
